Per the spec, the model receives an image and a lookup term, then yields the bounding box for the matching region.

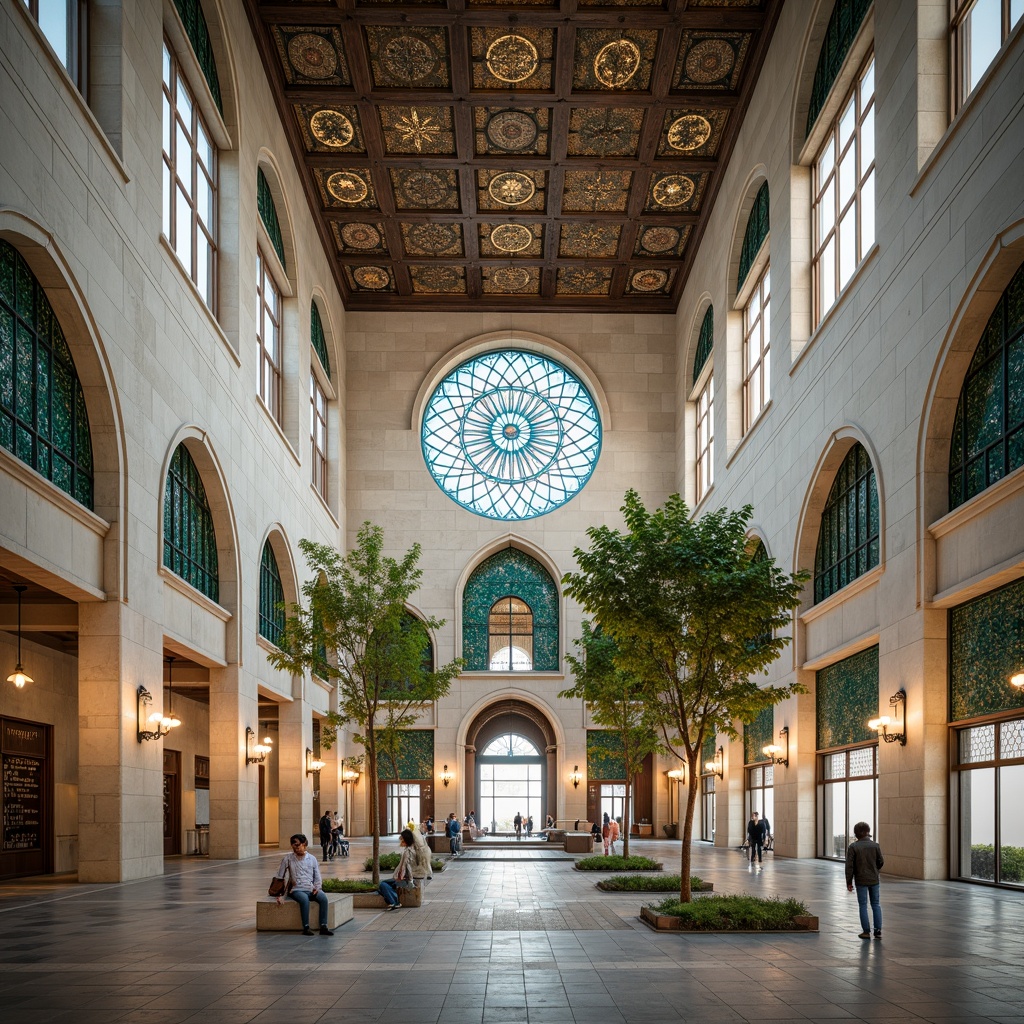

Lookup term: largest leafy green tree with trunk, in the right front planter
[562,490,808,902]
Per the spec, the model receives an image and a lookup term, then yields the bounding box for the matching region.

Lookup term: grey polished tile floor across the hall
[0,840,1024,1024]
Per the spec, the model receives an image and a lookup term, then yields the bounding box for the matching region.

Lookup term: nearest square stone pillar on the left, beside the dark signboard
[78,600,164,882]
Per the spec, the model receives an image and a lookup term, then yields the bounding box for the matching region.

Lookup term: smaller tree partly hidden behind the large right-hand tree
[558,620,659,857]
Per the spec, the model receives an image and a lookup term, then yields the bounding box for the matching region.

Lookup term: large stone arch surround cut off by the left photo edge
[0,209,129,600]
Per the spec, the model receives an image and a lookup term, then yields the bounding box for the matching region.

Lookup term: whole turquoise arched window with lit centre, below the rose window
[462,548,558,672]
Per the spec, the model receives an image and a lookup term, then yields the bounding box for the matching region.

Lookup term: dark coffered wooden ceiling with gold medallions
[245,0,781,312]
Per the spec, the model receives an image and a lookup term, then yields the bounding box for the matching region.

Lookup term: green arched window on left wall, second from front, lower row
[164,444,220,601]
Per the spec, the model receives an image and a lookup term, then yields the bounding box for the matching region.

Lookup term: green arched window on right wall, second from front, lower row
[814,444,880,603]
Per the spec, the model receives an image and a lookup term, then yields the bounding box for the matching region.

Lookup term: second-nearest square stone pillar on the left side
[210,665,259,860]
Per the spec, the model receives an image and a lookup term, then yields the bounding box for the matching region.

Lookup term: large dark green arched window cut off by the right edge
[949,258,1024,511]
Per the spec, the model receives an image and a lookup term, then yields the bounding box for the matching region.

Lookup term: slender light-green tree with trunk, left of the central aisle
[267,521,462,882]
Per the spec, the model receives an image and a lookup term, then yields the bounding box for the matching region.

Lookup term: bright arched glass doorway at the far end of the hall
[466,699,557,833]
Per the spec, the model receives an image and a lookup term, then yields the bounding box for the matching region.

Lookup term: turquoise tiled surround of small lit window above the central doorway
[462,548,558,672]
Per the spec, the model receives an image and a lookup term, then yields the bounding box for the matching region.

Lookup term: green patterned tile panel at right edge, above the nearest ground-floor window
[949,580,1024,722]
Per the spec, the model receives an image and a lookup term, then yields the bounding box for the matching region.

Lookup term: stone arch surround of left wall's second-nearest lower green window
[156,424,240,664]
